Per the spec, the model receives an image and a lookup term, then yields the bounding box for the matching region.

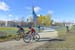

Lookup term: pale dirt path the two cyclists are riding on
[0,31,58,50]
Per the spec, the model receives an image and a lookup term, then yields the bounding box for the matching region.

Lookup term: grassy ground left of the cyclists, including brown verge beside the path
[0,27,28,42]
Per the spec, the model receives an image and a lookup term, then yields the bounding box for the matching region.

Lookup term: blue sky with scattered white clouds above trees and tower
[0,0,75,22]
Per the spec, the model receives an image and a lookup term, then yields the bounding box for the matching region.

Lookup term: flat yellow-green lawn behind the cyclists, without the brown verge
[0,27,28,35]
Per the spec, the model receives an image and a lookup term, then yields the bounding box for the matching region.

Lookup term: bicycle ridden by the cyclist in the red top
[23,33,40,43]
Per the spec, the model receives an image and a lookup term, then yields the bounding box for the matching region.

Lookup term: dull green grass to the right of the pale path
[35,27,75,50]
